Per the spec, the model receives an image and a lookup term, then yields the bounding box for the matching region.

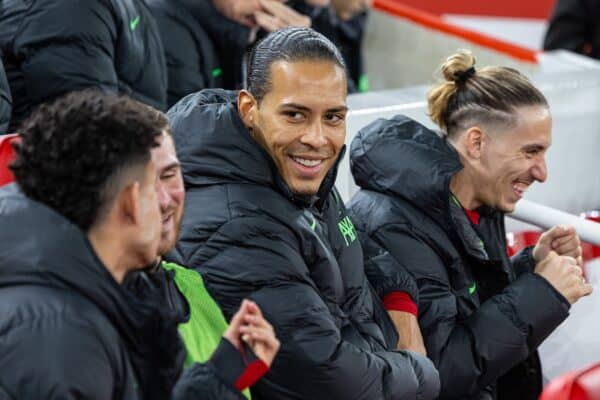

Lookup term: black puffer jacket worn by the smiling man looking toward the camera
[168,91,438,400]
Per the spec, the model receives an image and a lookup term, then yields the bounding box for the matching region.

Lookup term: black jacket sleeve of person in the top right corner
[544,0,597,53]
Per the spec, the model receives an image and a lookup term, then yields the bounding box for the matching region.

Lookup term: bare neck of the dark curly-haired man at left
[87,227,128,284]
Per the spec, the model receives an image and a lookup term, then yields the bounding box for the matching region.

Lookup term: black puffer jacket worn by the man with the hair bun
[349,116,569,400]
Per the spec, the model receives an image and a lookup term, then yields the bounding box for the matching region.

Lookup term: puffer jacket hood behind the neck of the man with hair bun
[350,115,463,230]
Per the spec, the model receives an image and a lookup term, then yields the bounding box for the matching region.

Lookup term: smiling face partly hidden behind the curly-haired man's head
[152,132,185,255]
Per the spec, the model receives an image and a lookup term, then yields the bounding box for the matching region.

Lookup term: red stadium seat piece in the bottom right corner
[540,364,600,400]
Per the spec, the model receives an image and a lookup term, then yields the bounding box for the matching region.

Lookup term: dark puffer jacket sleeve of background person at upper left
[14,0,118,108]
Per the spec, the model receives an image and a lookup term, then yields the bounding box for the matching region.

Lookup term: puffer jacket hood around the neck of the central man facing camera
[167,89,345,206]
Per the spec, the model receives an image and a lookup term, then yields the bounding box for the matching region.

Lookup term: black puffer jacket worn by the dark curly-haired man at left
[0,184,255,400]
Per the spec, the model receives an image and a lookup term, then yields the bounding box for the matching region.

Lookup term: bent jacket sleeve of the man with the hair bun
[390,232,569,399]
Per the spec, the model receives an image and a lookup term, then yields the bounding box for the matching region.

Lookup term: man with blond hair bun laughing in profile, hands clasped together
[349,51,592,400]
